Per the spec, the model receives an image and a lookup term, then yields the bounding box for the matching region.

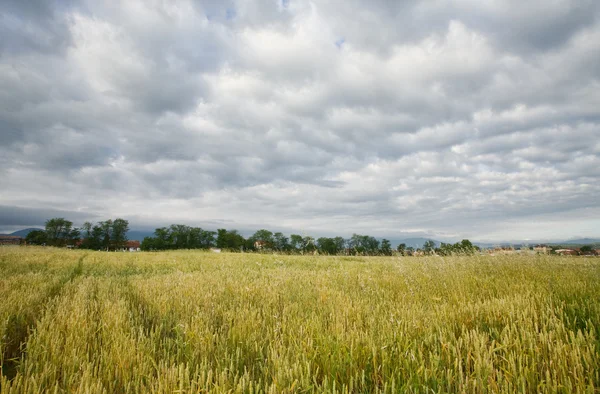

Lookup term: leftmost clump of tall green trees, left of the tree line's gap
[25,218,129,250]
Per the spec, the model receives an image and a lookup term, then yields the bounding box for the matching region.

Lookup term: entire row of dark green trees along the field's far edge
[26,218,478,256]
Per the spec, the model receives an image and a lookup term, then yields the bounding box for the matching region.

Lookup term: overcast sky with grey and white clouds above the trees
[0,0,600,241]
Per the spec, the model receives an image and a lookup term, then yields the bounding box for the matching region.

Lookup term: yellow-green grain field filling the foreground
[0,247,600,393]
